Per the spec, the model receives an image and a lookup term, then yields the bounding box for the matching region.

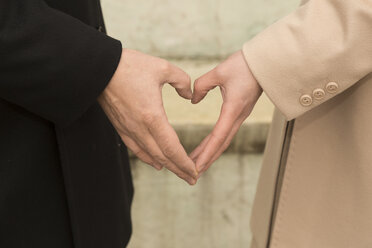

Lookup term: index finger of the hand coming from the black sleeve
[148,112,198,178]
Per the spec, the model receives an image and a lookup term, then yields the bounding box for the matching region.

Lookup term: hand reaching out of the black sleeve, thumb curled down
[98,49,198,185]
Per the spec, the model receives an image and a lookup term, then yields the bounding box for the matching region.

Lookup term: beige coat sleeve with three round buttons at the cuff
[243,0,372,120]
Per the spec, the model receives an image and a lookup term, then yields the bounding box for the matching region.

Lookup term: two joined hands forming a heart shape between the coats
[98,49,262,184]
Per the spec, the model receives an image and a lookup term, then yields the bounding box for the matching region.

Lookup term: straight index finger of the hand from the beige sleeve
[196,103,240,171]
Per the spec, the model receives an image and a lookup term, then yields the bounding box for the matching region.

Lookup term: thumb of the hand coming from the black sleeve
[167,64,192,100]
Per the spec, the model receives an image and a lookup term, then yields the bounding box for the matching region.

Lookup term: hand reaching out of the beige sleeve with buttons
[190,51,262,174]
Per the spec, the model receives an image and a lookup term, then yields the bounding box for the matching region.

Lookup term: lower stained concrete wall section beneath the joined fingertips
[129,154,262,248]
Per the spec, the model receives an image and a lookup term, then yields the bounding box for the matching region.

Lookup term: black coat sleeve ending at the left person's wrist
[0,0,122,126]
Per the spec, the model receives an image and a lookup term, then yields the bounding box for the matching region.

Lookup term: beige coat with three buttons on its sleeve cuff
[243,0,372,248]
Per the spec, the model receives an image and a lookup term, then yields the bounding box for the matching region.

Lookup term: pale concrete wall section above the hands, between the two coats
[102,0,299,58]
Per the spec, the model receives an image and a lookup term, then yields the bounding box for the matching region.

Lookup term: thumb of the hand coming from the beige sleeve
[191,69,218,104]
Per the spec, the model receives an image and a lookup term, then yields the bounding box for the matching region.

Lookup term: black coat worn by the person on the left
[0,0,133,248]
